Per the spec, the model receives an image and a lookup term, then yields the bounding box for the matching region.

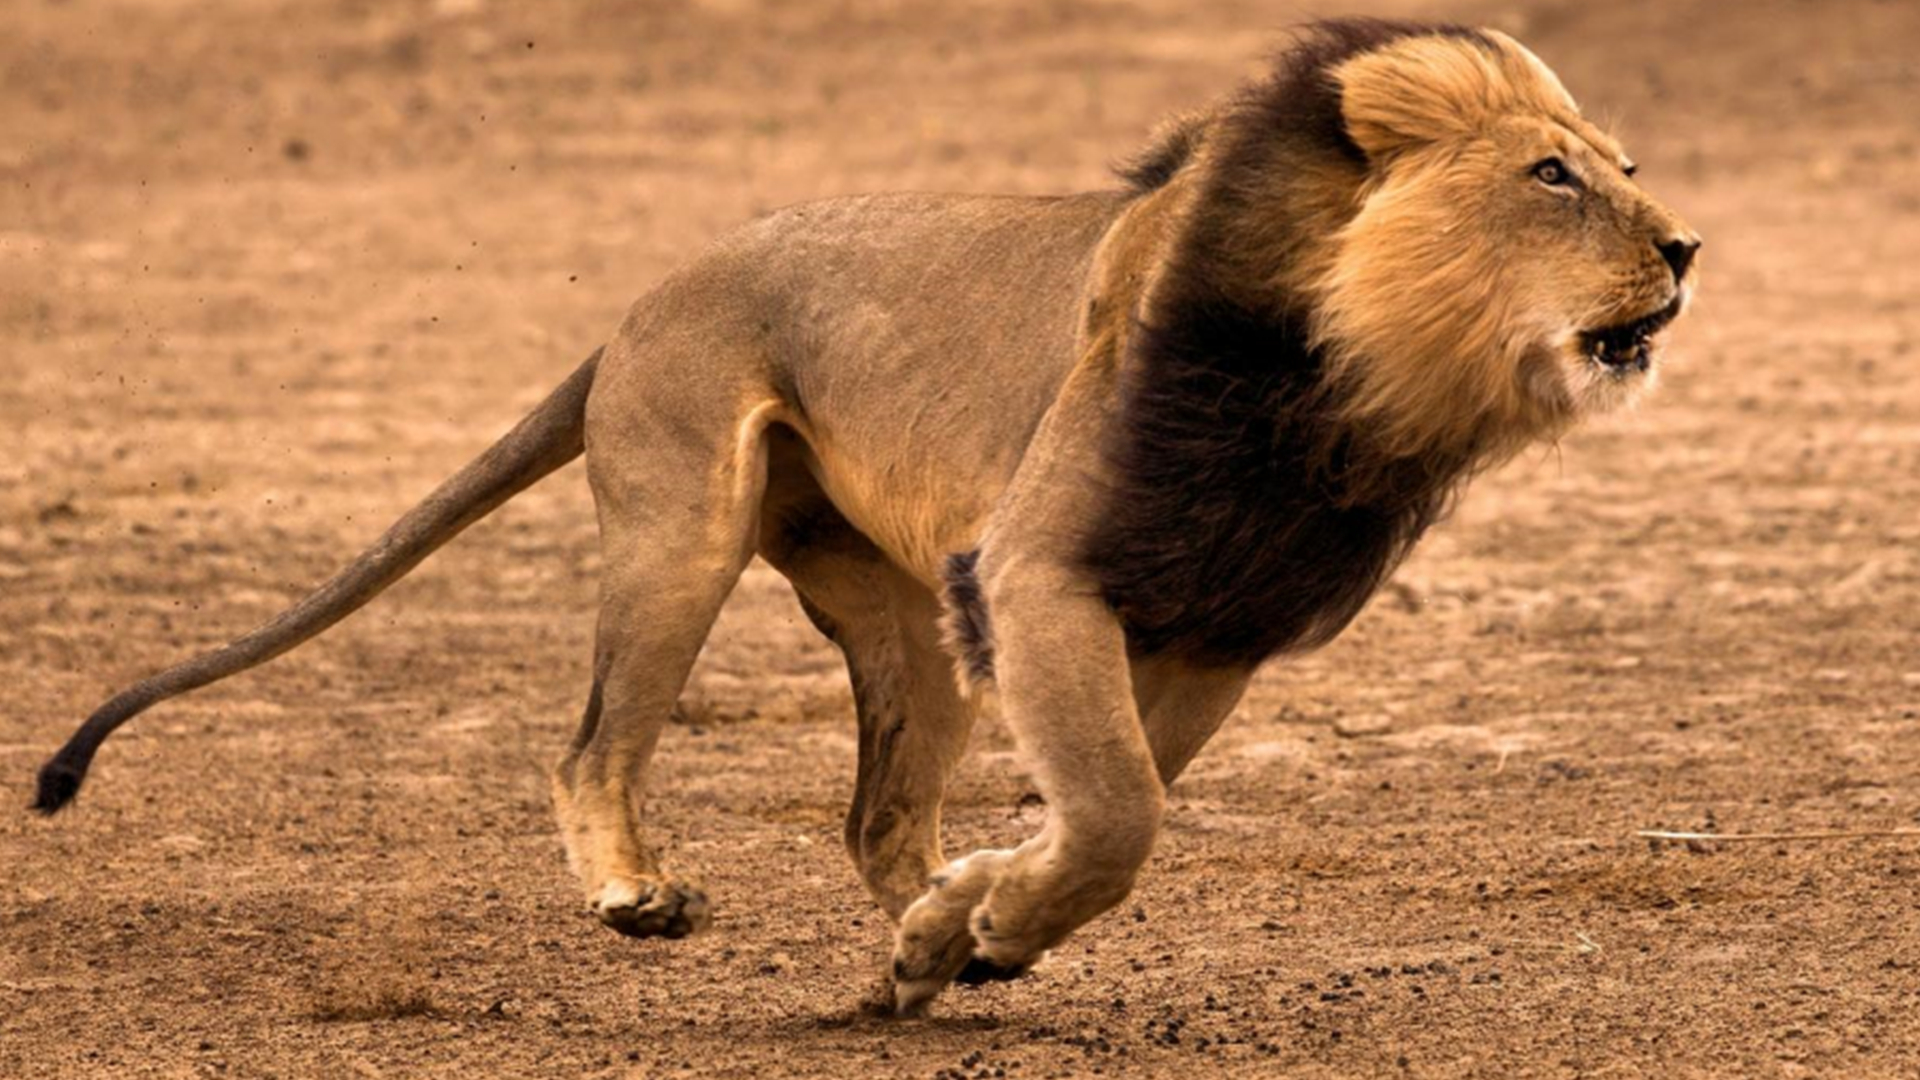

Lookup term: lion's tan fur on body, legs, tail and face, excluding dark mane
[42,21,1688,1011]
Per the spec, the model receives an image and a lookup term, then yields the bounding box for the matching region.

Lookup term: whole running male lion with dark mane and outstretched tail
[36,19,1699,1013]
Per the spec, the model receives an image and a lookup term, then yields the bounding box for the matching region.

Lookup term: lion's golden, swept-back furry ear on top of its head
[1332,37,1505,161]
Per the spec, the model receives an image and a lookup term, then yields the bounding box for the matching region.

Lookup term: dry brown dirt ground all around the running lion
[0,0,1920,1078]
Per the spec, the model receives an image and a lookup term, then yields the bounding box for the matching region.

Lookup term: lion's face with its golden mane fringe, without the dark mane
[1317,33,1699,452]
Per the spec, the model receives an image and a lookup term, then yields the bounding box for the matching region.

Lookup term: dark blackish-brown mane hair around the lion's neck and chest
[1083,19,1478,665]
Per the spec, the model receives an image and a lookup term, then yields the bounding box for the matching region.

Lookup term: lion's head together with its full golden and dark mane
[1085,19,1699,667]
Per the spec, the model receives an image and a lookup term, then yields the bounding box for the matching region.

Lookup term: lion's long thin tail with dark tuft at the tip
[33,350,601,813]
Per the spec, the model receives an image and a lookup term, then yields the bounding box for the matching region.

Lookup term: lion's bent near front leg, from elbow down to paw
[893,557,1164,1013]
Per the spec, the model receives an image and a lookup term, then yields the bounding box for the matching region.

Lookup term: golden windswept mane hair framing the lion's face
[1311,31,1605,459]
